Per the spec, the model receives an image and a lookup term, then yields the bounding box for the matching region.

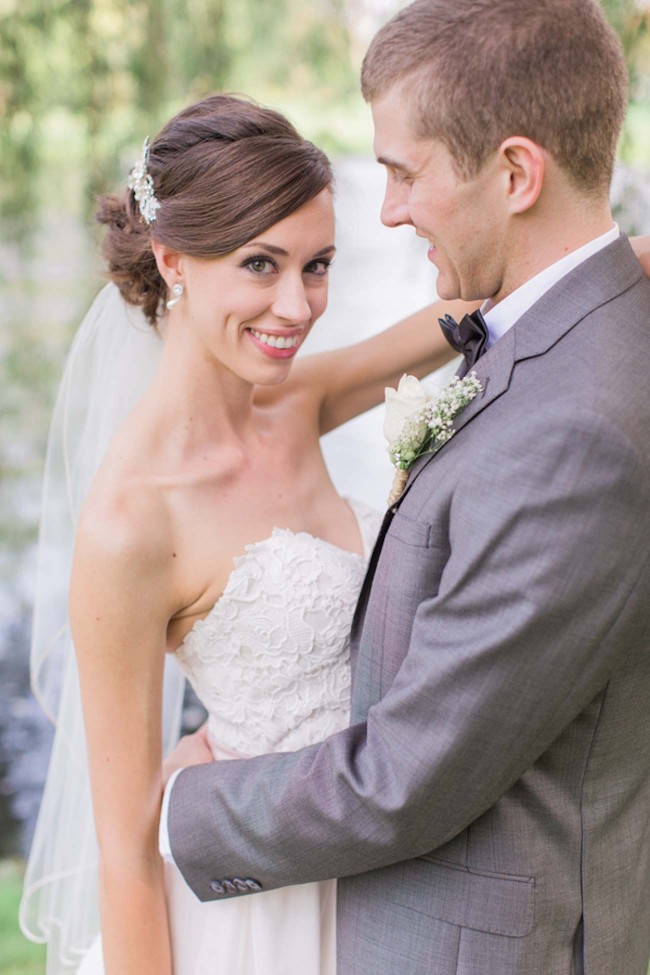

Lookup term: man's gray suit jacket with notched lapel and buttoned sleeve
[170,239,650,975]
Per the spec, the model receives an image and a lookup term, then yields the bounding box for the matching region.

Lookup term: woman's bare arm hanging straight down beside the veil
[70,498,172,975]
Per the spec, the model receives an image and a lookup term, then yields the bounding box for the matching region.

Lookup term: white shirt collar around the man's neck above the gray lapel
[481,223,620,349]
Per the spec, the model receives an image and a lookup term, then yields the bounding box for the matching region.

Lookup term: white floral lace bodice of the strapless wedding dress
[176,501,381,756]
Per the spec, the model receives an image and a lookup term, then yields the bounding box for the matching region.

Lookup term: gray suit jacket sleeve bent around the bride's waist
[170,409,650,900]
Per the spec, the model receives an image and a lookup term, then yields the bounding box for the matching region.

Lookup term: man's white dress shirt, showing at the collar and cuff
[158,224,620,863]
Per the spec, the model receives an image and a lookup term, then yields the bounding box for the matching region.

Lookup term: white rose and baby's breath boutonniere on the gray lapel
[384,372,483,505]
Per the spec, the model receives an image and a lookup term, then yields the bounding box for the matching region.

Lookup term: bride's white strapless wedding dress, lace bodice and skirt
[80,501,381,975]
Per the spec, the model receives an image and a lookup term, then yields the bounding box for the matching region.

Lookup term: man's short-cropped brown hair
[361,0,628,192]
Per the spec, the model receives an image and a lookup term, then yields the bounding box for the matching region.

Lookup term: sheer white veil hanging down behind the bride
[20,284,184,975]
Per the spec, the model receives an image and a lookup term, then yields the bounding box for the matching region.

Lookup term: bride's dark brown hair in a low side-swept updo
[97,95,333,325]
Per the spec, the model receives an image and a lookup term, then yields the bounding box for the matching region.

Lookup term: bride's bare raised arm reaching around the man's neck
[287,301,479,434]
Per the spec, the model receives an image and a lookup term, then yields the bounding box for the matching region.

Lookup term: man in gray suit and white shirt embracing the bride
[161,0,650,975]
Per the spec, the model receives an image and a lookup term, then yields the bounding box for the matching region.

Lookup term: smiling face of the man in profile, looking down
[372,87,507,300]
